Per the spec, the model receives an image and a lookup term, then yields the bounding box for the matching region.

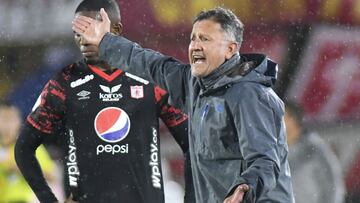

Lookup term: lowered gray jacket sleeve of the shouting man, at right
[228,87,282,202]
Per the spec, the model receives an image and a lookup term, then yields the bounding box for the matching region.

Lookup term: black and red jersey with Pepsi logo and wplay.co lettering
[27,62,187,203]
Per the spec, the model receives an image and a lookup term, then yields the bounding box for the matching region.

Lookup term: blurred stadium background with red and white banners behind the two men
[0,0,360,202]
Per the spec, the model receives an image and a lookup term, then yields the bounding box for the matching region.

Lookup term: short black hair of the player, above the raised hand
[75,0,121,20]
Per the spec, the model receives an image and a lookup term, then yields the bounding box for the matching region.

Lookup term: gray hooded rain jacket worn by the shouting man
[100,34,294,203]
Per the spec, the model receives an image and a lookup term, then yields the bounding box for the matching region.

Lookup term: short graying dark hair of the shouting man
[193,7,244,48]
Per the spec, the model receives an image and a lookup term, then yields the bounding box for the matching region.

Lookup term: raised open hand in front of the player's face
[72,8,110,46]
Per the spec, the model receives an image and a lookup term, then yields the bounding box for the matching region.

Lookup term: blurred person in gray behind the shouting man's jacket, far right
[285,101,345,203]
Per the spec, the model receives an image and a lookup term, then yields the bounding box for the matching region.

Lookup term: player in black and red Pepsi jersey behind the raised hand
[15,0,187,203]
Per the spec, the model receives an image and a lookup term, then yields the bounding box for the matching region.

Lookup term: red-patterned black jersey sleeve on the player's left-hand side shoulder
[27,75,66,134]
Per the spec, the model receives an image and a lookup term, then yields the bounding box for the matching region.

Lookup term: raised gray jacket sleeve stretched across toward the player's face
[99,33,191,112]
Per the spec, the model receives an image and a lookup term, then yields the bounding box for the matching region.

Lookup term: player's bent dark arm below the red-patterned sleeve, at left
[15,124,57,202]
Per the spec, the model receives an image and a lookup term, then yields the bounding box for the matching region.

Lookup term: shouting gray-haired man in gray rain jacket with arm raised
[73,8,294,203]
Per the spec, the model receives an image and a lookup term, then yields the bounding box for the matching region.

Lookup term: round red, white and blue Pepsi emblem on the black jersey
[94,107,130,143]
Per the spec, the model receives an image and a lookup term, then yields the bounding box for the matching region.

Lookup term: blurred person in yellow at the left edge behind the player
[0,102,56,203]
